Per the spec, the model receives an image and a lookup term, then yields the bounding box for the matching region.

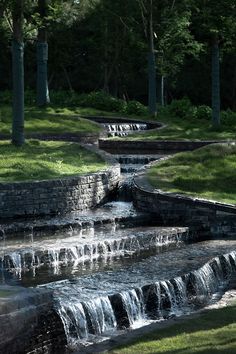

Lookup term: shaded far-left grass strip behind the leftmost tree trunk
[0,106,101,134]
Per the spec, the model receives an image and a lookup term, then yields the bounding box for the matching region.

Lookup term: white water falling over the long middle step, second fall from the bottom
[0,228,188,279]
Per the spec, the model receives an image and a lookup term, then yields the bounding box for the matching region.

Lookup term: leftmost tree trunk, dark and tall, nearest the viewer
[12,0,25,146]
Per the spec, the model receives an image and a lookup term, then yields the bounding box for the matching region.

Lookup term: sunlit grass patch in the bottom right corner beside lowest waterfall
[109,304,236,354]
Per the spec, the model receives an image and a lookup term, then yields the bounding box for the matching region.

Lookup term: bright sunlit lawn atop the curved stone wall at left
[0,140,106,182]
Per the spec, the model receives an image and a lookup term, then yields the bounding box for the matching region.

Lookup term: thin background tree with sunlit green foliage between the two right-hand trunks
[156,0,202,105]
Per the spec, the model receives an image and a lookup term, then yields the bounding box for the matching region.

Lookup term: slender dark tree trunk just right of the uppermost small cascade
[148,0,157,117]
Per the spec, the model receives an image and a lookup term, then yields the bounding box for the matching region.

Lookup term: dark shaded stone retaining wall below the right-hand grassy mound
[133,168,236,236]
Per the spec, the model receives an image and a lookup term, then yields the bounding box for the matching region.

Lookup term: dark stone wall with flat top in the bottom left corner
[0,285,67,354]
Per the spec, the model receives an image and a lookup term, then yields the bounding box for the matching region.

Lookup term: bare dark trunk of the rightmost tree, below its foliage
[212,38,220,128]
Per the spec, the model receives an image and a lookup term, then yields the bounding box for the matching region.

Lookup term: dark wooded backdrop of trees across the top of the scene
[0,0,236,141]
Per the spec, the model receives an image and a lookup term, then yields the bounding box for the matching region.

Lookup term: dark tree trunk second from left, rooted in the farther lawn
[37,0,50,107]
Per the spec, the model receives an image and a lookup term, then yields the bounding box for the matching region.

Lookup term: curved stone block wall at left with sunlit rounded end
[0,147,120,218]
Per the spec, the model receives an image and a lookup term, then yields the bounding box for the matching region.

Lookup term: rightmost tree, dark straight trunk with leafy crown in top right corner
[193,0,236,128]
